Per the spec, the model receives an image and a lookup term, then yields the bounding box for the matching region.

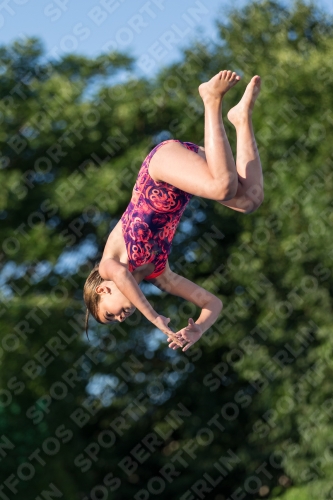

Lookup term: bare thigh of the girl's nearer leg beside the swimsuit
[149,142,221,200]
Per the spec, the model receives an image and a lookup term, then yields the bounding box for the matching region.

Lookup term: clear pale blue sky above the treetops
[0,0,333,76]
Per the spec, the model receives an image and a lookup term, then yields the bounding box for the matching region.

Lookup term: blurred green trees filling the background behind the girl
[0,1,333,500]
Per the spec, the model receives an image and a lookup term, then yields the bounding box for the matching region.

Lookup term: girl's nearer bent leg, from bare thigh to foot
[149,71,240,200]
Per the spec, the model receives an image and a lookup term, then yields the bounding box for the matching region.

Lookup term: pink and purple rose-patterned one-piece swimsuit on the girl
[121,139,199,280]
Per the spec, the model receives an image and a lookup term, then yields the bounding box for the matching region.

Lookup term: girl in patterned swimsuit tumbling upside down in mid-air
[84,70,263,351]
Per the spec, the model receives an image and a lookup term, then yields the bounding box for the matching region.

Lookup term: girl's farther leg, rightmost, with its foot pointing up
[220,76,263,213]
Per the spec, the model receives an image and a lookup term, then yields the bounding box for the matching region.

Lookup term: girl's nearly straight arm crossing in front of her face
[99,259,181,346]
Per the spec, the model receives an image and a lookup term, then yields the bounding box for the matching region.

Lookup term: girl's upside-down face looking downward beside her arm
[96,281,135,324]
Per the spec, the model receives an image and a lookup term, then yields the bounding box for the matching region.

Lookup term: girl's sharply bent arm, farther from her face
[151,264,223,350]
